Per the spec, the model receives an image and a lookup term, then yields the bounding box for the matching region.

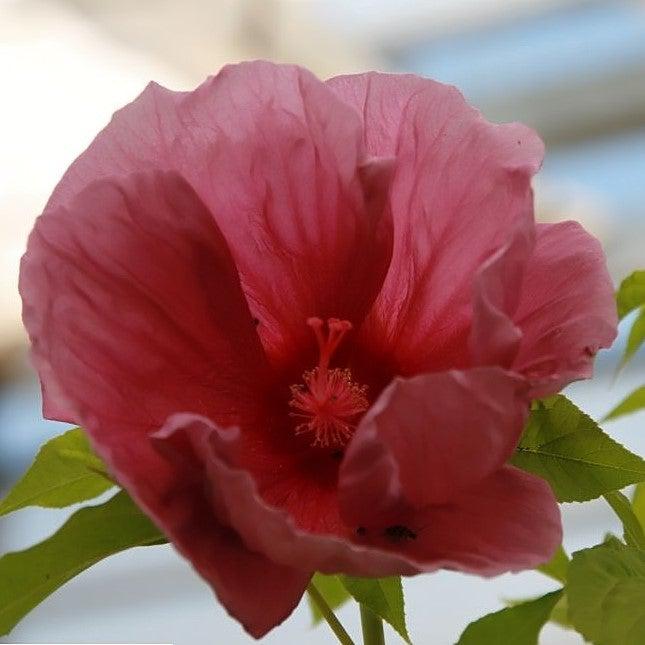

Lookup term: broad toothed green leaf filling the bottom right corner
[567,539,645,645]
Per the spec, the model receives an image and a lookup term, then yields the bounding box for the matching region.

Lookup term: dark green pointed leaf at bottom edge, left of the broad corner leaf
[457,589,562,645]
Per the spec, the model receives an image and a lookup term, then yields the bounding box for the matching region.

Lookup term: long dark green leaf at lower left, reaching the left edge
[0,491,166,635]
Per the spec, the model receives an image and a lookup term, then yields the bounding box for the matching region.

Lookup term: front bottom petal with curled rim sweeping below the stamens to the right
[155,414,561,576]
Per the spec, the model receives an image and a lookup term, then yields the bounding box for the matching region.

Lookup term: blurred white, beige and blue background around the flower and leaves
[0,0,645,645]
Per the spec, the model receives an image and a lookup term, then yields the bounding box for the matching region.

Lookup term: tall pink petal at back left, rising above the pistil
[44,61,392,376]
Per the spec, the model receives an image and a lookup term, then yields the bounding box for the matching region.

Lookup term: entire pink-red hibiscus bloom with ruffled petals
[20,62,616,637]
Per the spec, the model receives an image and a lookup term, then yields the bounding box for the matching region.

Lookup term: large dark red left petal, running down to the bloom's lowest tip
[21,167,310,637]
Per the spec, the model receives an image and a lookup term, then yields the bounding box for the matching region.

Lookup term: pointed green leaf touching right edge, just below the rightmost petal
[511,395,645,502]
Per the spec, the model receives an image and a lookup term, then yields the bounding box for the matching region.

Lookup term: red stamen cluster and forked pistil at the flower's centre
[289,318,369,448]
